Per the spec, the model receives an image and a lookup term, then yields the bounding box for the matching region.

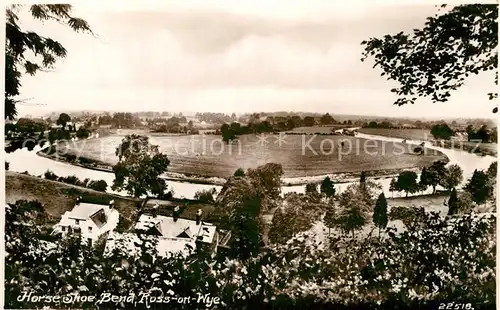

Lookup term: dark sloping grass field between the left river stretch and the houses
[5,171,214,223]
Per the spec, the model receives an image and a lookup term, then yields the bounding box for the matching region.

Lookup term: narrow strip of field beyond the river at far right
[359,128,497,155]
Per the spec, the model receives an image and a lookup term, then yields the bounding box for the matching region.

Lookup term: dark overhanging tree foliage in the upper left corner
[5,4,92,120]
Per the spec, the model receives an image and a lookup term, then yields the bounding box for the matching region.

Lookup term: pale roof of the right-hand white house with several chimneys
[135,214,216,243]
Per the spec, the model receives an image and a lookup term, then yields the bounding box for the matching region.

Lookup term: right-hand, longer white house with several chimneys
[105,207,218,257]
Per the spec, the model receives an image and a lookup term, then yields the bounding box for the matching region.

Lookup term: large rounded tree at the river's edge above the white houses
[111,134,170,198]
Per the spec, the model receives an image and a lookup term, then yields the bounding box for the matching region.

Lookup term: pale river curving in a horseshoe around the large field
[5,133,497,199]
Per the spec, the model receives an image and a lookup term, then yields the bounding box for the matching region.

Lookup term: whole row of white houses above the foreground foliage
[53,199,219,257]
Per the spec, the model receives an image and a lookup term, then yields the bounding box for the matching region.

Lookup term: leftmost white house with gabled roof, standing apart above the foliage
[53,198,120,244]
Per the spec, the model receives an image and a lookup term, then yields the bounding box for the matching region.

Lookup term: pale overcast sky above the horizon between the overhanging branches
[14,0,494,117]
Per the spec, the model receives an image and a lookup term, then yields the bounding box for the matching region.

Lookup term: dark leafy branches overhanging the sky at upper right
[361,4,498,113]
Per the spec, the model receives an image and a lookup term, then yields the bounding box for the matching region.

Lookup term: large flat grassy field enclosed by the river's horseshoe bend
[53,134,444,177]
